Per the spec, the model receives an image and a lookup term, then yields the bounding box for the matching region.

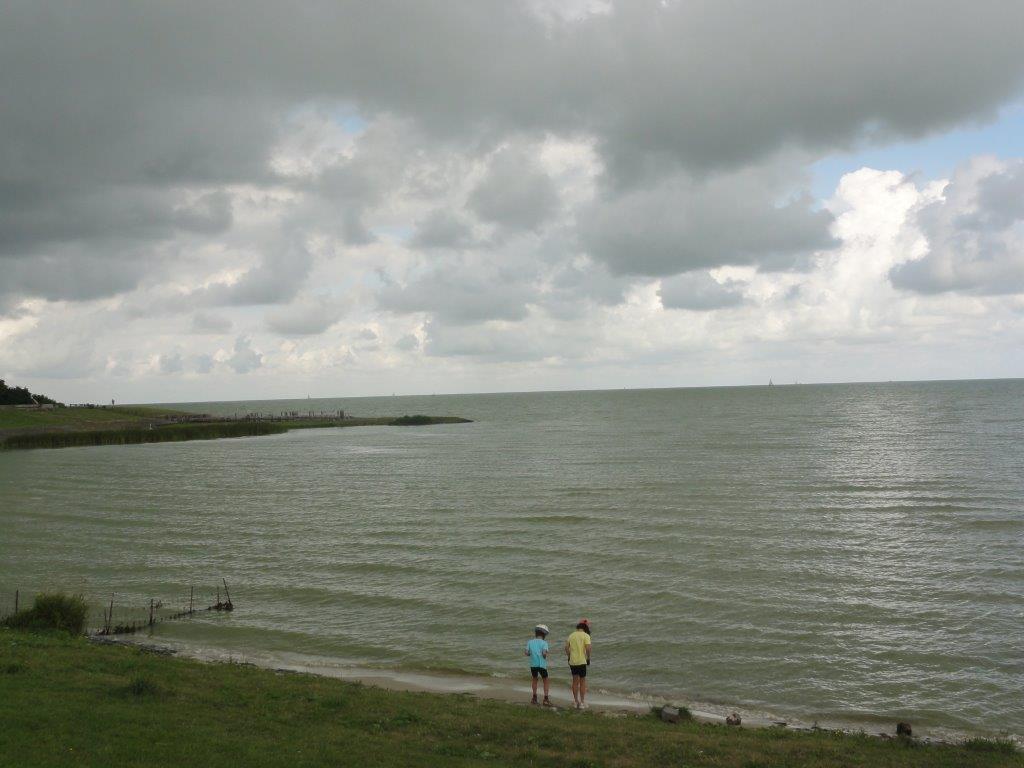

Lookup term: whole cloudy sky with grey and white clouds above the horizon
[0,0,1024,401]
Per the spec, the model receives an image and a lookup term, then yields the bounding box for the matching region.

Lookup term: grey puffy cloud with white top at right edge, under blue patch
[890,159,1024,295]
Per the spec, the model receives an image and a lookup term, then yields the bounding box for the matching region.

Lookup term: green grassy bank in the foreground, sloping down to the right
[0,630,1024,768]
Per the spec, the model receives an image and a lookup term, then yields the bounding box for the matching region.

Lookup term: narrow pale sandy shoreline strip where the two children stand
[88,635,1024,750]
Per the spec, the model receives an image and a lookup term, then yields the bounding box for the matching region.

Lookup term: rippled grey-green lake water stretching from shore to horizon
[0,381,1024,734]
